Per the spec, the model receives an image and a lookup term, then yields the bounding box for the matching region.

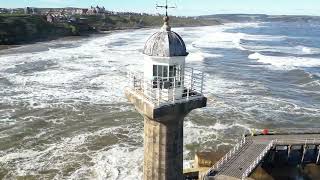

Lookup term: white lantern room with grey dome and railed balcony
[129,16,204,106]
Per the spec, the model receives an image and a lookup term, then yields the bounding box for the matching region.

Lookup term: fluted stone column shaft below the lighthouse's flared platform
[143,117,184,180]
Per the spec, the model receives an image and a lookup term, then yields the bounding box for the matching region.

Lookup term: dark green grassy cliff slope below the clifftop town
[0,15,220,45]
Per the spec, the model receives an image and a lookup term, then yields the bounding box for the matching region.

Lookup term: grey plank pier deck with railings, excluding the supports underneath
[204,133,320,179]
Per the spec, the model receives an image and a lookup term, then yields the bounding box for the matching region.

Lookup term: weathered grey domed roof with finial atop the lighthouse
[143,17,188,57]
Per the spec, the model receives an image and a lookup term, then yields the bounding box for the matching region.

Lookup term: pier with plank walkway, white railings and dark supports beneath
[201,132,320,180]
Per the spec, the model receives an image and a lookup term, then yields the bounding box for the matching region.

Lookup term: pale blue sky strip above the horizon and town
[0,0,320,16]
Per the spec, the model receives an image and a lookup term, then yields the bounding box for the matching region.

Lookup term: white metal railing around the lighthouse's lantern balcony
[127,68,204,106]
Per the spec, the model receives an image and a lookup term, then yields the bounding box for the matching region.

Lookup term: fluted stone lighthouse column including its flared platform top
[126,89,207,180]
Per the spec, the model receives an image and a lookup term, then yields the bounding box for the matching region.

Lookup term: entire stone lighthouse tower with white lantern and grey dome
[125,16,207,180]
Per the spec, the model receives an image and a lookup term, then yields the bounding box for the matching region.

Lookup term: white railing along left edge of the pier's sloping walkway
[206,137,246,176]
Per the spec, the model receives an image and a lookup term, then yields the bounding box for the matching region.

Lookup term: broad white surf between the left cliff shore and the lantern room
[0,31,150,108]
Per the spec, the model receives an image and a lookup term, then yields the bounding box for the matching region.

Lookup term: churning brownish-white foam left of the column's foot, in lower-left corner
[0,126,143,179]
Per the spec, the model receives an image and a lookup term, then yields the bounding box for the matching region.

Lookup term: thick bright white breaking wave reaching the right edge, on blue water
[248,53,320,70]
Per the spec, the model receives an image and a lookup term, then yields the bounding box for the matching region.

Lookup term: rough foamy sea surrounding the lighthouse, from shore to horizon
[0,21,320,180]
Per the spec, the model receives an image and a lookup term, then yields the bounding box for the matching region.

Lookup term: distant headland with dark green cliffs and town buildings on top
[0,6,221,45]
